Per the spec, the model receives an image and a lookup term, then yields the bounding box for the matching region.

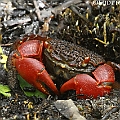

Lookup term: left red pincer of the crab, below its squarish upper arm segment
[14,58,59,94]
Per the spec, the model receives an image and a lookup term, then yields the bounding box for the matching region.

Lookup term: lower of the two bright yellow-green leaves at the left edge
[0,84,11,97]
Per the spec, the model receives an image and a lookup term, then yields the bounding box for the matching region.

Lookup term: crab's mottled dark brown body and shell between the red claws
[43,39,105,80]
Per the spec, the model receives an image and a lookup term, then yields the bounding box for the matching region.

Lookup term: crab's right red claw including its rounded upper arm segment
[60,64,115,99]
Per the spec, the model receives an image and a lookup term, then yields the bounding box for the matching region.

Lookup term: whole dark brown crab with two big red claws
[7,35,115,99]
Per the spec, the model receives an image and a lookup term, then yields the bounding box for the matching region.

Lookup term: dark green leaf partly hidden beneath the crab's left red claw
[18,75,46,99]
